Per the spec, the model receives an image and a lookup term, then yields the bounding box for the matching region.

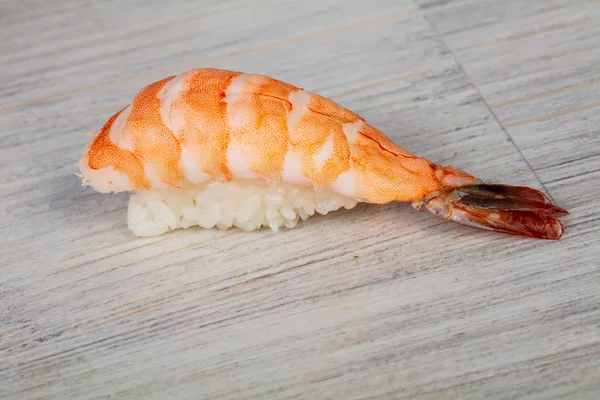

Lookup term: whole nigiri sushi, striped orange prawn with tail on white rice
[78,68,567,239]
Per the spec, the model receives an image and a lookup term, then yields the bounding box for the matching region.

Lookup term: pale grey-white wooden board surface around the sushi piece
[0,0,600,400]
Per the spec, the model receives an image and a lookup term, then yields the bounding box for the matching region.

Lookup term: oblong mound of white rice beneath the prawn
[127,179,357,236]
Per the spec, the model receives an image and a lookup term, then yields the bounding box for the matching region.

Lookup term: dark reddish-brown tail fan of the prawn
[425,184,568,240]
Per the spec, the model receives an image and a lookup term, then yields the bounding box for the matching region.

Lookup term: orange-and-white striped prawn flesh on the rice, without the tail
[80,69,448,203]
